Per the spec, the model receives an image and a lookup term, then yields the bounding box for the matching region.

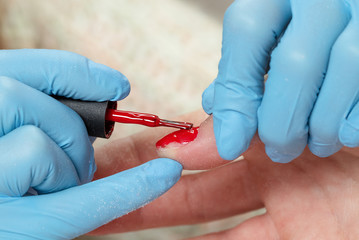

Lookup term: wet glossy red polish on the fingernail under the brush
[156,127,199,148]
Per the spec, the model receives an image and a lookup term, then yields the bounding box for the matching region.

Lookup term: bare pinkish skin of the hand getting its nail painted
[92,112,359,240]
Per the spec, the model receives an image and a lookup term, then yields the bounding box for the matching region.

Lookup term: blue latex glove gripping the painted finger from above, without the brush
[203,0,359,163]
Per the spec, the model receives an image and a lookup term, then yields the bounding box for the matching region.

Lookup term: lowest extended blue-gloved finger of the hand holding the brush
[0,159,182,239]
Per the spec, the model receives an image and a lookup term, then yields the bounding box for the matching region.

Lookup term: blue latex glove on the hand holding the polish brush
[0,50,182,239]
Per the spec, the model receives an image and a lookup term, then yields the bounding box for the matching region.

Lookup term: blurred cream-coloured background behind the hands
[0,0,264,240]
